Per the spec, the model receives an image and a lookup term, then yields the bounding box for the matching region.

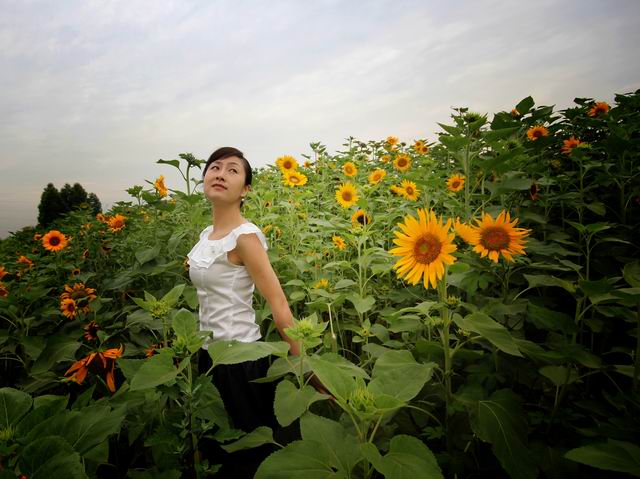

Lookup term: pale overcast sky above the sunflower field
[0,0,640,237]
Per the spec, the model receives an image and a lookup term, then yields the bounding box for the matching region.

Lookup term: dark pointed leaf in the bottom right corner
[564,439,640,477]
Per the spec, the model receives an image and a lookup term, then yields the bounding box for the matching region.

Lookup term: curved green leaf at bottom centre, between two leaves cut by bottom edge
[300,413,362,476]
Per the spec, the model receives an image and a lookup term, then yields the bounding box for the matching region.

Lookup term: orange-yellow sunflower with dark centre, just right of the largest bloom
[471,211,529,263]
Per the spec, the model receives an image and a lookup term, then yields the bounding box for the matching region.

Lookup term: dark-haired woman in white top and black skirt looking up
[188,147,299,432]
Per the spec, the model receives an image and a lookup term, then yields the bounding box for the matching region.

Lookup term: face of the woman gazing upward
[203,156,249,203]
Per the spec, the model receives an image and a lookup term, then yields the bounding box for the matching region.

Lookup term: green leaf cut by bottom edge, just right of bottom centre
[362,434,444,479]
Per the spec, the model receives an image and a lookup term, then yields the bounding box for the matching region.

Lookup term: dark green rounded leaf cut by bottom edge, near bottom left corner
[20,436,88,479]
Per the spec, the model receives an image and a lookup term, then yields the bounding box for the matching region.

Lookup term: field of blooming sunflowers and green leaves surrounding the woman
[0,91,640,479]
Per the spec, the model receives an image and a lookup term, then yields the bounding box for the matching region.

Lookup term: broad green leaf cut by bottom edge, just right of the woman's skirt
[254,440,347,479]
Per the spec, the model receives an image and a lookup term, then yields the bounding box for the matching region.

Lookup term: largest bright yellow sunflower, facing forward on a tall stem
[389,208,456,289]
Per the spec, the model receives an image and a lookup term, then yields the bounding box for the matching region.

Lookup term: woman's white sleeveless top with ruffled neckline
[187,223,267,349]
